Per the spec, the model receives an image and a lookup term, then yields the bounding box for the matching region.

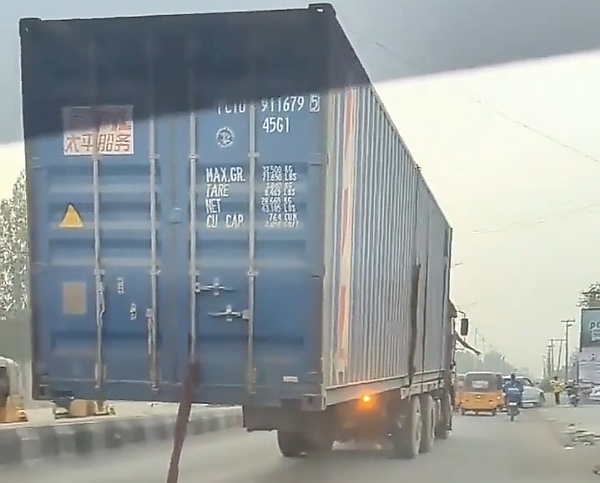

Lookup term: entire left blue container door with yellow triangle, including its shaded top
[21,26,189,401]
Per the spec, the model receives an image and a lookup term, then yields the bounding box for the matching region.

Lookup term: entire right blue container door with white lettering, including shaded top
[185,9,328,405]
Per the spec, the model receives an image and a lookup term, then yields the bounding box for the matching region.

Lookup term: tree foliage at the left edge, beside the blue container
[0,172,30,359]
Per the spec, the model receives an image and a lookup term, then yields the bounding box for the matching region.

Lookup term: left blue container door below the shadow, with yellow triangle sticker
[29,105,178,400]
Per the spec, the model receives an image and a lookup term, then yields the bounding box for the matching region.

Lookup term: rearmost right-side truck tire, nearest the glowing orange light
[392,396,423,459]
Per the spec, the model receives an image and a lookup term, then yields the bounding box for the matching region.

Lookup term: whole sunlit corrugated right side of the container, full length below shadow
[323,75,451,399]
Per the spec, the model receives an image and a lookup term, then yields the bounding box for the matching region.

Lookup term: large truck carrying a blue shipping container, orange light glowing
[20,4,468,458]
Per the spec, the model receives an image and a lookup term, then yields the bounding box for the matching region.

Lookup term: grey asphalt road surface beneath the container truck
[2,410,600,483]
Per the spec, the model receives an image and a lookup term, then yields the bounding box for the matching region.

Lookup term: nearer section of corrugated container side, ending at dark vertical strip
[323,85,418,392]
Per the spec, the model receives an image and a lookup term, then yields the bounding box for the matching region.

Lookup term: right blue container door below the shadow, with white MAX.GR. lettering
[189,94,323,404]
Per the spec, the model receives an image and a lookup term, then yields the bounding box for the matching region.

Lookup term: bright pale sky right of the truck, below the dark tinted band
[380,54,600,374]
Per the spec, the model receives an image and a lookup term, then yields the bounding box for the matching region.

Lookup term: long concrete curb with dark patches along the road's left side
[0,407,242,468]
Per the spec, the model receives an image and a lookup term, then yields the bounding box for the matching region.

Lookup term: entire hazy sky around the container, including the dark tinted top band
[0,0,600,369]
